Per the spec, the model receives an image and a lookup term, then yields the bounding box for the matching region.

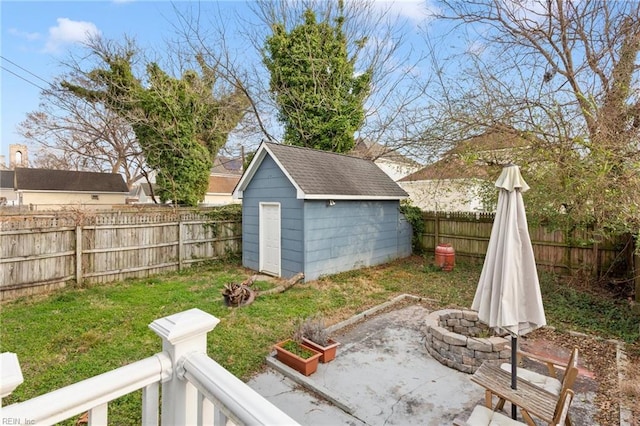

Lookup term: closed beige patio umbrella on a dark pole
[471,165,546,419]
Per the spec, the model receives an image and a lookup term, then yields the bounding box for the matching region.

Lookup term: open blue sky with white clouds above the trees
[0,0,440,166]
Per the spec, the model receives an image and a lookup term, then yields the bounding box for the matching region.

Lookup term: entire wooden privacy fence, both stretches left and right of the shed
[0,208,640,300]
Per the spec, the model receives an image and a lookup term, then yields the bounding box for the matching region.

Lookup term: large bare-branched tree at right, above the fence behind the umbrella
[438,0,640,240]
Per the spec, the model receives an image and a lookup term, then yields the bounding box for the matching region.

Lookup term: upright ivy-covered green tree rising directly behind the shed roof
[263,3,372,152]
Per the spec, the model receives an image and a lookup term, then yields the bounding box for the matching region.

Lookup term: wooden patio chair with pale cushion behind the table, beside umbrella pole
[500,348,578,395]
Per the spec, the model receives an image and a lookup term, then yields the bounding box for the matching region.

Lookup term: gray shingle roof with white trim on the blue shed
[234,142,408,200]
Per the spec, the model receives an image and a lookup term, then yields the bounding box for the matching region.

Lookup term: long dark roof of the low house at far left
[15,167,129,193]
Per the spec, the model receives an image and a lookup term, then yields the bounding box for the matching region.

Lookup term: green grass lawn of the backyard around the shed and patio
[0,256,640,425]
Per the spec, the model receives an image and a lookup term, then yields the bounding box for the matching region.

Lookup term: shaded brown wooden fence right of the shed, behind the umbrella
[422,212,633,277]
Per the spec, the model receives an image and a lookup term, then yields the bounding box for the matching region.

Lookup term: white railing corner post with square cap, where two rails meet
[149,309,220,426]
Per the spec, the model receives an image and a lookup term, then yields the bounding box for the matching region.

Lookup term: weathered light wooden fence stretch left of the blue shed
[0,208,242,300]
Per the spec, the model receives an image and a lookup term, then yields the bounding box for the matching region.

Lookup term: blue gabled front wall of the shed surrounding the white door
[242,155,304,277]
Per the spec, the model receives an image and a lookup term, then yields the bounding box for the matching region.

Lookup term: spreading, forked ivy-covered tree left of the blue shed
[62,42,246,206]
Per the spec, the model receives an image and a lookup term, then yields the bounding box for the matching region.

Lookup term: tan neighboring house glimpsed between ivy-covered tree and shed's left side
[202,156,242,206]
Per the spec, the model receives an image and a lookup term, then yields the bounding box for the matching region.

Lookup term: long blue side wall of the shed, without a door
[304,200,411,280]
